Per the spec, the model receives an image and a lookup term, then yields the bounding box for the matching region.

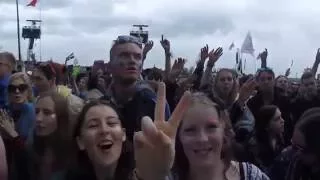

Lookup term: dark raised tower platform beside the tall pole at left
[22,20,41,63]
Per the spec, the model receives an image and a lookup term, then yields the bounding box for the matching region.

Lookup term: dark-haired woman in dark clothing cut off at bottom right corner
[270,107,320,180]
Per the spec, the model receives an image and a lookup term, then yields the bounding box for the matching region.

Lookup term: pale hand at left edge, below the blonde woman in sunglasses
[0,109,18,138]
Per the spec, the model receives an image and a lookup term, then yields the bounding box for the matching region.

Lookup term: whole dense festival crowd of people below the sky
[0,36,320,180]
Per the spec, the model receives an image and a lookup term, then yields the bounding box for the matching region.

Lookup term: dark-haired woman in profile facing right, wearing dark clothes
[248,105,284,172]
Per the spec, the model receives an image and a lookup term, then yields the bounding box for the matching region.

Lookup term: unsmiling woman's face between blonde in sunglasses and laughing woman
[35,96,58,136]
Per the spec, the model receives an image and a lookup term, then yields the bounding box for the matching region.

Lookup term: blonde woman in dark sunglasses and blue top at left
[0,72,36,179]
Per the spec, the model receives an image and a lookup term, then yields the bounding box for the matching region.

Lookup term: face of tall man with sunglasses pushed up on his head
[110,43,142,82]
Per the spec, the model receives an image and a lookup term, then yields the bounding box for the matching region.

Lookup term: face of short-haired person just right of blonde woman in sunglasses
[31,69,52,92]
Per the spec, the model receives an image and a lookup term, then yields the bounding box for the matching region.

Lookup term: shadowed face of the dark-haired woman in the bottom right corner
[291,128,317,166]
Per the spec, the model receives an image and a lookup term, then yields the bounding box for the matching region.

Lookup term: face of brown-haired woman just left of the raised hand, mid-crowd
[217,71,234,94]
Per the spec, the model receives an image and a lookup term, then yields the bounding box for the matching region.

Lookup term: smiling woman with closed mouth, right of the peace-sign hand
[173,94,269,180]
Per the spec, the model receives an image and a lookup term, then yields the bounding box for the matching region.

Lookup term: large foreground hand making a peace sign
[134,83,191,180]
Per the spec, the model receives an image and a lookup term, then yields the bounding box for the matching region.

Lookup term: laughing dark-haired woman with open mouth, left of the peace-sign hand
[65,101,133,180]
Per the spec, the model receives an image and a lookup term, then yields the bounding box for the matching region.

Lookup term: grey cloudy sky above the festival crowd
[0,0,320,76]
